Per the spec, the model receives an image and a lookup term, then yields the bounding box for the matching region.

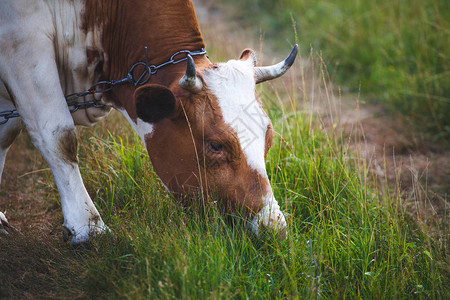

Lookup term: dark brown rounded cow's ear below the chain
[134,84,175,123]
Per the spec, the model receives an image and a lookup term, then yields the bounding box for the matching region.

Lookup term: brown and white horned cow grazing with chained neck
[0,0,298,244]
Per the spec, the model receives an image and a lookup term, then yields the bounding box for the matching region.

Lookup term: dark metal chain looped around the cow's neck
[0,47,206,125]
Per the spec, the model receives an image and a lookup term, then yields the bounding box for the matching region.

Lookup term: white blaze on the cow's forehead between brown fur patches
[203,59,270,177]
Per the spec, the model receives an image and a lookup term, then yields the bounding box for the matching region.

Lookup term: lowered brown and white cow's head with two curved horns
[135,46,297,234]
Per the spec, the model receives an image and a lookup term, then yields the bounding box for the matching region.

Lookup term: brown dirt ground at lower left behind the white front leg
[0,134,83,299]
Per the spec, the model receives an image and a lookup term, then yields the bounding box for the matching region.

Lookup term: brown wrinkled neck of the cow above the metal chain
[85,0,204,84]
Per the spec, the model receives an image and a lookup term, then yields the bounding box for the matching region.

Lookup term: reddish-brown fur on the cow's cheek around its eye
[147,91,269,214]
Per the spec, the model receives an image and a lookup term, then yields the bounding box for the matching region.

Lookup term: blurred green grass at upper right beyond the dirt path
[216,0,450,141]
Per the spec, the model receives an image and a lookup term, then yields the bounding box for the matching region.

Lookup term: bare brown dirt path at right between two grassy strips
[338,100,450,240]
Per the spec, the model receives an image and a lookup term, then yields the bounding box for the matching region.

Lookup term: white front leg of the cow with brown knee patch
[0,33,106,243]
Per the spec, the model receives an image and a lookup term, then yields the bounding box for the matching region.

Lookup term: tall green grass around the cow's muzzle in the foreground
[64,47,449,299]
